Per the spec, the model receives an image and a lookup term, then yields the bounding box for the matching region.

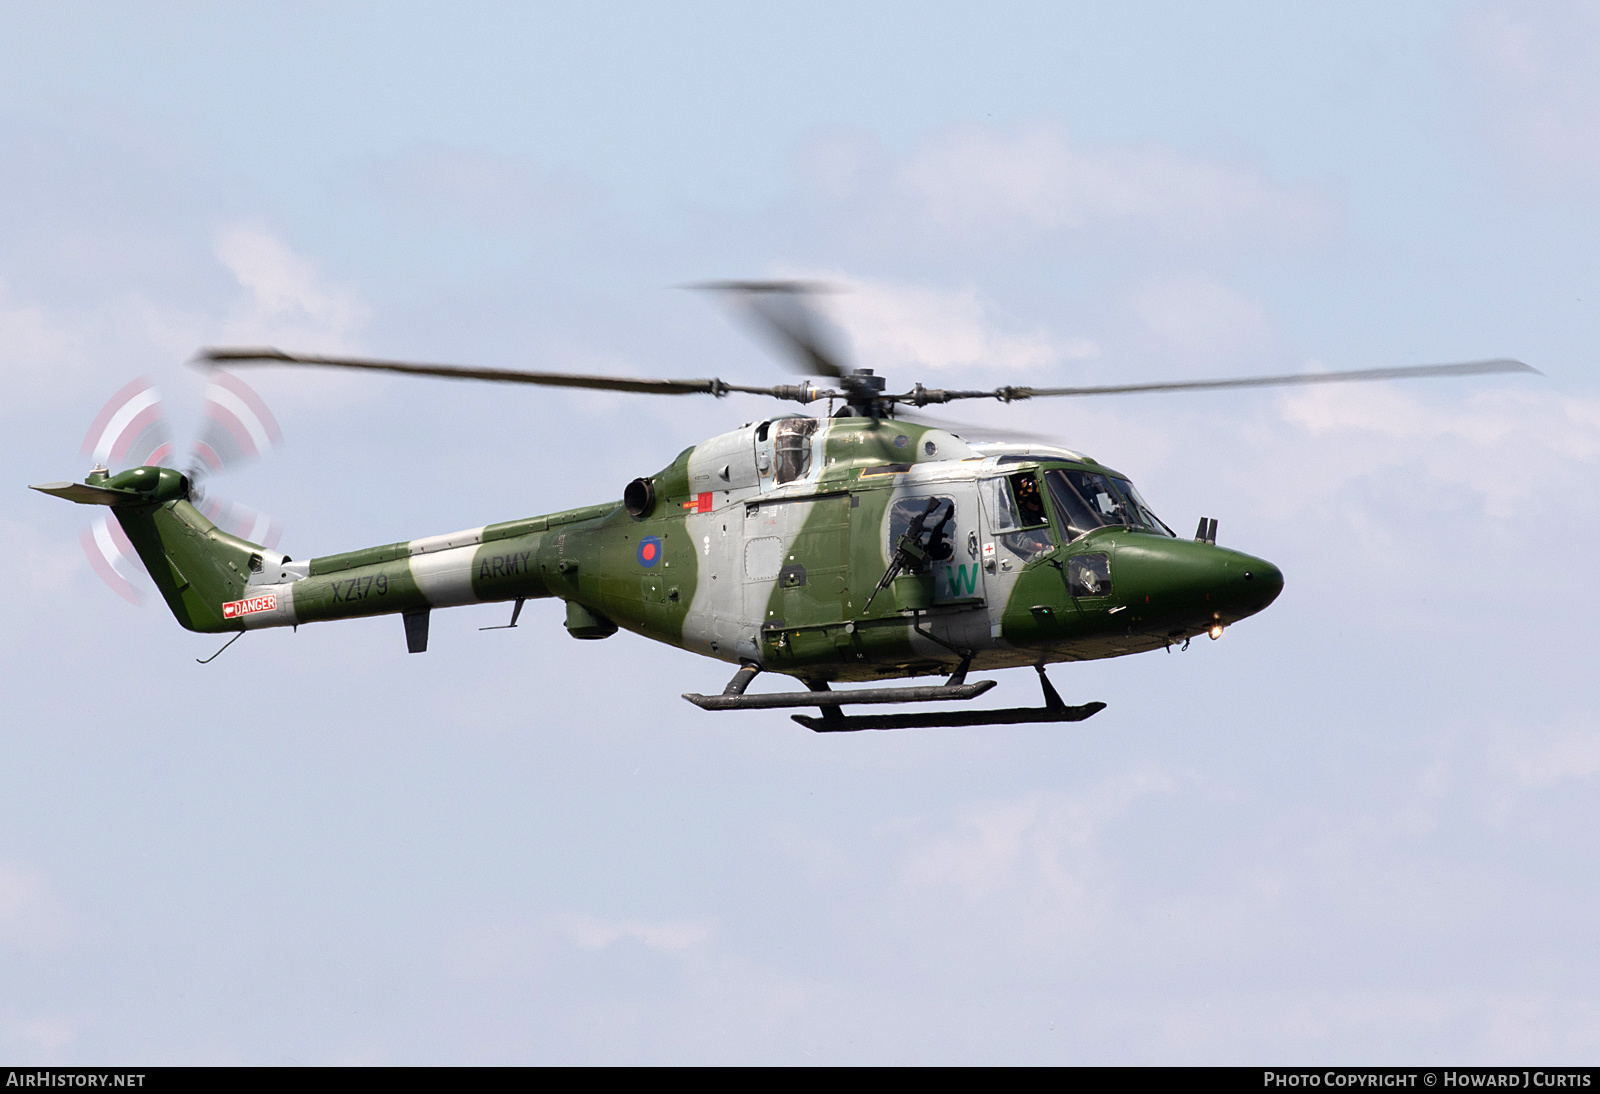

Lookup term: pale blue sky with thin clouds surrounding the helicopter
[0,3,1600,1064]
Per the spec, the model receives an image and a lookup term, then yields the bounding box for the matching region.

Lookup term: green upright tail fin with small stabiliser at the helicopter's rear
[34,467,268,633]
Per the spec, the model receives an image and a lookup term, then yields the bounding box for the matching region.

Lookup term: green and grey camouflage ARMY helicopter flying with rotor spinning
[34,281,1536,731]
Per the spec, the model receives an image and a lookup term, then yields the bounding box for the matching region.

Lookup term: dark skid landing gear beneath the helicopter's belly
[683,662,1106,733]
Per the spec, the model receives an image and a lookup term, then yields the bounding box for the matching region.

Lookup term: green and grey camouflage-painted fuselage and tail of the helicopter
[37,417,1282,681]
